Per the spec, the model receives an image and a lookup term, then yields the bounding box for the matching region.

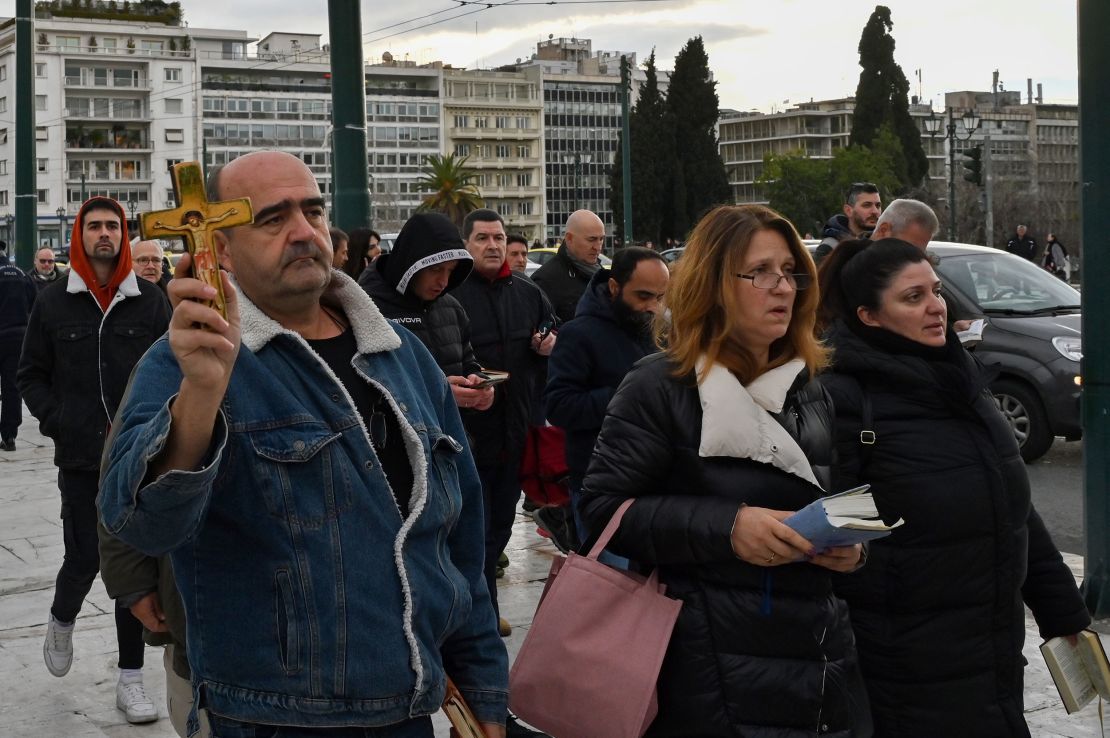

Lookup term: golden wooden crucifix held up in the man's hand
[139,161,254,320]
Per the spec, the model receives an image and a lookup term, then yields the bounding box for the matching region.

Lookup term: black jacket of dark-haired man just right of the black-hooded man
[453,265,557,466]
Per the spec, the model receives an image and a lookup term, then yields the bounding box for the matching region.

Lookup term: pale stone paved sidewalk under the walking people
[0,406,1110,738]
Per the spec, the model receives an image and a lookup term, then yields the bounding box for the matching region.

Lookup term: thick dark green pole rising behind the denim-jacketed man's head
[327,0,370,232]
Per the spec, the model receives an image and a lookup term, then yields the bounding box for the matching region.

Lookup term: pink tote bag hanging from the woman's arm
[508,499,682,738]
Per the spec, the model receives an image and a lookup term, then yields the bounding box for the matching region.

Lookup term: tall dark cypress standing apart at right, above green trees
[849,6,929,187]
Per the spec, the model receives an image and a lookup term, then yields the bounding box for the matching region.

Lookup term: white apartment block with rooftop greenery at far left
[0,8,204,245]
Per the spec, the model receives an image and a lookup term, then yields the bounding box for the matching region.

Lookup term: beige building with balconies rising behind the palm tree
[443,69,545,241]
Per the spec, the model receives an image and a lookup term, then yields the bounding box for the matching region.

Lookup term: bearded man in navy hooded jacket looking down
[544,246,670,540]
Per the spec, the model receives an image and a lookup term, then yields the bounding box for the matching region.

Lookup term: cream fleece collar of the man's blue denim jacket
[232,270,401,354]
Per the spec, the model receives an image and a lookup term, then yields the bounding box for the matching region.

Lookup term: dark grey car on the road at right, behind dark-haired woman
[806,241,1083,462]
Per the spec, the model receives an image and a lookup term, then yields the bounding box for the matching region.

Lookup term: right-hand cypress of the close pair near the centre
[663,36,731,239]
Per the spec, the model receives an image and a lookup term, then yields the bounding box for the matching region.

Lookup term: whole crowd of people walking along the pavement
[0,156,1090,738]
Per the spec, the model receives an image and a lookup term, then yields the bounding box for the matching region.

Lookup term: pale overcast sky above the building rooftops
[10,0,1078,112]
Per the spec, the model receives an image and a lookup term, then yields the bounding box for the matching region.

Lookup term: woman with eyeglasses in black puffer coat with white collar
[582,205,870,738]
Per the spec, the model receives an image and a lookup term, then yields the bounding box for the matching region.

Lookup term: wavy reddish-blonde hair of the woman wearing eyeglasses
[656,205,829,384]
